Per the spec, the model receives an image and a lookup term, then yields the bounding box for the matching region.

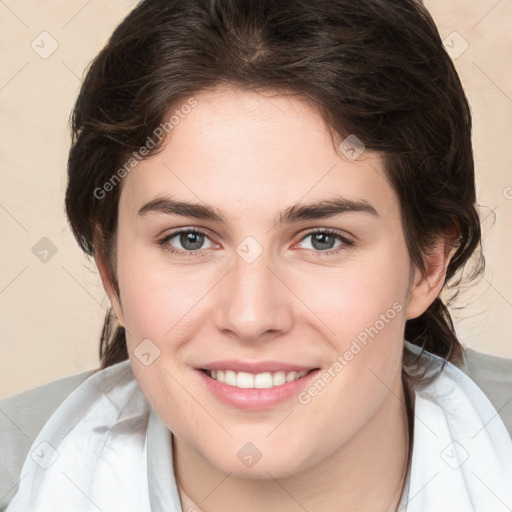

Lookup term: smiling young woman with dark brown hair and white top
[3,0,512,512]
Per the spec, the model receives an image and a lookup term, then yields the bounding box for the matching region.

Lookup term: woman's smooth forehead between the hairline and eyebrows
[121,87,396,220]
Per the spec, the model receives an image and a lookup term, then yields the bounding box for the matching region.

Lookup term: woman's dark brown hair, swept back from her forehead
[66,0,483,380]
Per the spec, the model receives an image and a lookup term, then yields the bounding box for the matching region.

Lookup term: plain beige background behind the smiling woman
[0,0,512,398]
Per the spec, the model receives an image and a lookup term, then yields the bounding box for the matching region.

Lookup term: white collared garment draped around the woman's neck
[5,342,512,512]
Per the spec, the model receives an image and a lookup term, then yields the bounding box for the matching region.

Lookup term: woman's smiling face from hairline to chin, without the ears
[107,88,428,478]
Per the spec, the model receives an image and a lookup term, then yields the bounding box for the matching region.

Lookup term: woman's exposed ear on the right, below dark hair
[406,234,456,320]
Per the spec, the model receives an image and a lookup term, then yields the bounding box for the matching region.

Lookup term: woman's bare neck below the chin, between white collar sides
[173,374,410,512]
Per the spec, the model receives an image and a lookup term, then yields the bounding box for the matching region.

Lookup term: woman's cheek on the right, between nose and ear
[288,241,410,400]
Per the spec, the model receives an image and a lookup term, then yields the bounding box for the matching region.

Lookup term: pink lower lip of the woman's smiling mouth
[197,370,319,411]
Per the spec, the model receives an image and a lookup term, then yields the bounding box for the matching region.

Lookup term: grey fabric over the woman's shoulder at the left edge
[0,370,95,509]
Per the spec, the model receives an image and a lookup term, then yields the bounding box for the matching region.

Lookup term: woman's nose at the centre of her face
[214,246,294,342]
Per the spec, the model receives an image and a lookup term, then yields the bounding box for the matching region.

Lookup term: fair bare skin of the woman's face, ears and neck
[96,88,449,512]
